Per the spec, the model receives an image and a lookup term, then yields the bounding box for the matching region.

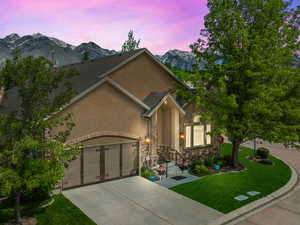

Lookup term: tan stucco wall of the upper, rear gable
[110,53,176,100]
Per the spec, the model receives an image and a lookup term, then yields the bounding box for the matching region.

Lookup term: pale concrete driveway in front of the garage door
[63,176,223,225]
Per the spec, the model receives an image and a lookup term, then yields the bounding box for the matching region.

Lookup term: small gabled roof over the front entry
[143,92,185,117]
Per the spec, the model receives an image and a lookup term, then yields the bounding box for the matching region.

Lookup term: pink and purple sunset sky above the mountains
[0,0,207,54]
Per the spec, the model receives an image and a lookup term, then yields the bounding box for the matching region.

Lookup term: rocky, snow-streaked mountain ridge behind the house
[0,33,197,71]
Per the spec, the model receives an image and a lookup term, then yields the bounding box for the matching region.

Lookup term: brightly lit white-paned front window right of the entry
[185,115,211,148]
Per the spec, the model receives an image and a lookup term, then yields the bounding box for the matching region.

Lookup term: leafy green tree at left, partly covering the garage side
[0,54,79,223]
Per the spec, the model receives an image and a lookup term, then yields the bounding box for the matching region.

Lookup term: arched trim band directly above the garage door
[67,131,142,144]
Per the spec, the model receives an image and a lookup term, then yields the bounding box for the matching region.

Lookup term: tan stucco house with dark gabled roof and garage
[3,49,216,188]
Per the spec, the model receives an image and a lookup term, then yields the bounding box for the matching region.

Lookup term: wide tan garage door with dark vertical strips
[63,142,139,189]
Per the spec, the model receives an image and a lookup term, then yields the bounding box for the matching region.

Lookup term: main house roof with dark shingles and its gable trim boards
[0,48,189,117]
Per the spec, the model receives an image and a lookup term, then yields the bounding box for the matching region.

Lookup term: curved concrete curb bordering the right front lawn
[207,151,299,225]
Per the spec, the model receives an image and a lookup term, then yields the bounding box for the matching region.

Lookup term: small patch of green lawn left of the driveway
[0,195,96,225]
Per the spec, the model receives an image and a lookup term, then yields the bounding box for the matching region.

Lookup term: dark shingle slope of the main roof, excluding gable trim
[0,49,144,114]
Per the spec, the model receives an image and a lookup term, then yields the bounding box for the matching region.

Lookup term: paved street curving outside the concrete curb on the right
[234,143,300,225]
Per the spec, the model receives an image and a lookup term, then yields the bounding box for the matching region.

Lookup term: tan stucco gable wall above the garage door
[54,83,147,143]
